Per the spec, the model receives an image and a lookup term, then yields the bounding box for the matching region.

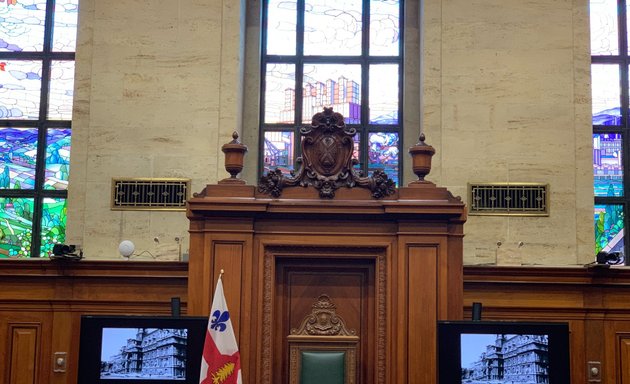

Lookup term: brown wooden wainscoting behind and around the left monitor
[0,259,187,384]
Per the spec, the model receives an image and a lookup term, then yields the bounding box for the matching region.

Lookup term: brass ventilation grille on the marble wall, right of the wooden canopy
[468,183,549,216]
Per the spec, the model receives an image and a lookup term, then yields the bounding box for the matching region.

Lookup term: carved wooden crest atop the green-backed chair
[291,294,356,336]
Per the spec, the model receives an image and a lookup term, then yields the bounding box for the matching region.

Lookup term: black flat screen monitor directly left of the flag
[78,315,208,384]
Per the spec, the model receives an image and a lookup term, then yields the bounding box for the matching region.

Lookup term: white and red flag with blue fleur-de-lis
[199,275,242,384]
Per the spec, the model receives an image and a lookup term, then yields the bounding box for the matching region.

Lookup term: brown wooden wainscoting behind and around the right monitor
[464,266,630,384]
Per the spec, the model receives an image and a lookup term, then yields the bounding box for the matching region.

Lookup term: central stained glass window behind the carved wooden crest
[259,0,403,183]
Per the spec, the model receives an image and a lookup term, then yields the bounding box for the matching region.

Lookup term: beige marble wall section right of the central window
[422,0,594,265]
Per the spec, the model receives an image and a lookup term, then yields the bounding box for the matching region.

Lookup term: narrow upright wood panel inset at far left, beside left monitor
[8,323,41,384]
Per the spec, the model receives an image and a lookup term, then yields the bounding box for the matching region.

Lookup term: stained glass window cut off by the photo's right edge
[590,0,630,263]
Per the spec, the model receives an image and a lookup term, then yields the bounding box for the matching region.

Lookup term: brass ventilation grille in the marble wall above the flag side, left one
[112,179,190,211]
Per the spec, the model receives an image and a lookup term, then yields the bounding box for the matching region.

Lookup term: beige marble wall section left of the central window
[67,0,245,258]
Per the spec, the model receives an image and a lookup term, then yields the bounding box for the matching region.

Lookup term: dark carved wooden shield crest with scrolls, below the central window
[258,108,395,199]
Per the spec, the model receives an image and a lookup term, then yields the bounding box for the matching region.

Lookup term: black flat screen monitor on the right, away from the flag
[438,321,570,384]
